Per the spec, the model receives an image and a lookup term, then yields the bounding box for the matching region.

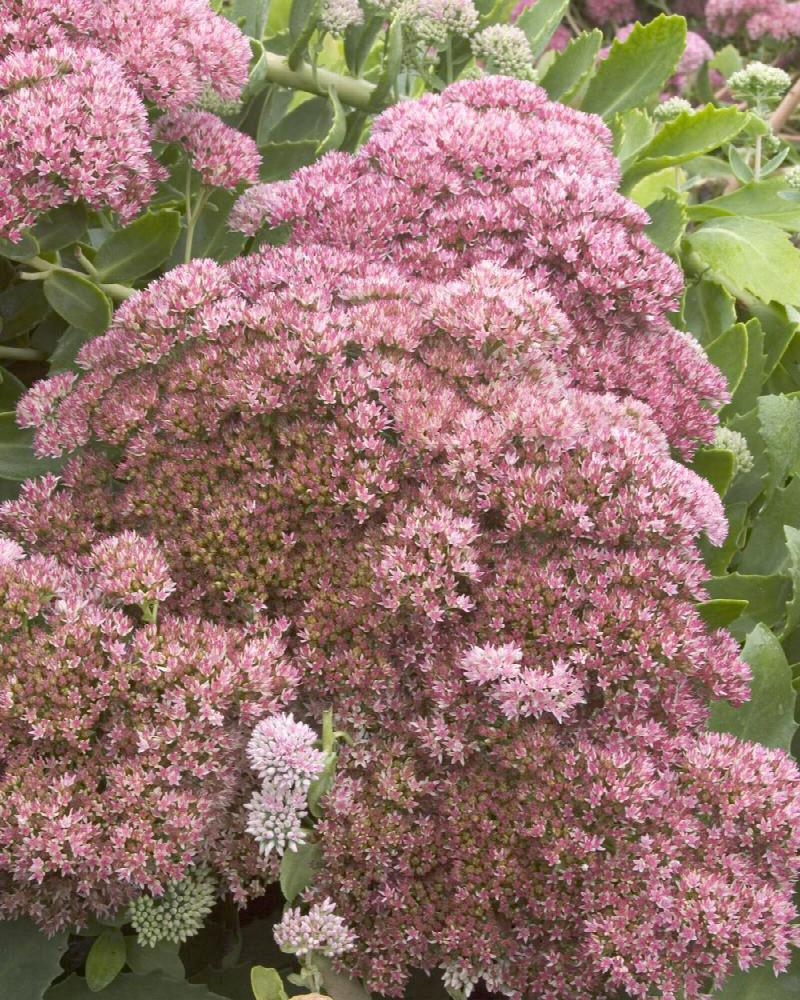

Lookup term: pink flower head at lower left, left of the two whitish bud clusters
[0,532,297,930]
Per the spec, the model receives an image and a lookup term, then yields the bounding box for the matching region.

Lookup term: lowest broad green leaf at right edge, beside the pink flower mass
[709,625,797,751]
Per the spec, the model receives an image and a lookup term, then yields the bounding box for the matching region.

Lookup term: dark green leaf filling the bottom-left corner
[0,919,67,1000]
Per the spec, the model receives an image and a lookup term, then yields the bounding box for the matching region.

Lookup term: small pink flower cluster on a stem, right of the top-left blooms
[156,111,261,188]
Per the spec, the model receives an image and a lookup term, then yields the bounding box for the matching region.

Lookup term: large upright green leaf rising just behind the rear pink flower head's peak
[581,14,686,118]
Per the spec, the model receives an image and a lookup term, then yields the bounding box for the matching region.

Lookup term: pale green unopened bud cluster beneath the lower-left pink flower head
[129,866,218,948]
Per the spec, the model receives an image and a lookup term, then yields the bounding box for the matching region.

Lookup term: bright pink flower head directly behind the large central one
[232,77,726,453]
